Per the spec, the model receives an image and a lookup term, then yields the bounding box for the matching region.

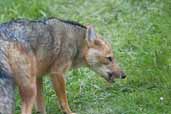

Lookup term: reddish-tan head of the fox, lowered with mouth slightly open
[85,26,126,82]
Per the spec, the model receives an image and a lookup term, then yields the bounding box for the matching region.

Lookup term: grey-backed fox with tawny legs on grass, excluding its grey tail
[0,18,126,114]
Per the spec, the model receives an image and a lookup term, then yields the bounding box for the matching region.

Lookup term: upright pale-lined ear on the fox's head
[86,25,96,44]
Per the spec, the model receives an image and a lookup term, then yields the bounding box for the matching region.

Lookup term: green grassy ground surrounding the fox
[0,0,171,114]
